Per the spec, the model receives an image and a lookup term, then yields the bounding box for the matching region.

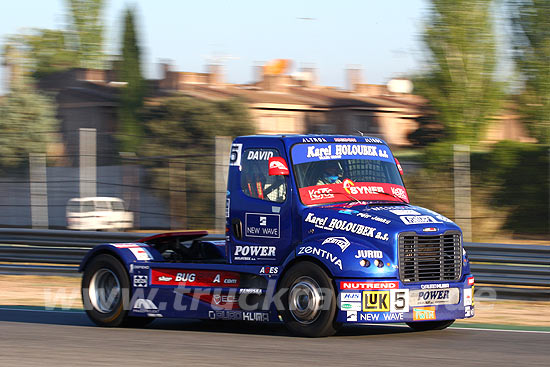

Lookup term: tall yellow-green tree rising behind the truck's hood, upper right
[415,0,502,146]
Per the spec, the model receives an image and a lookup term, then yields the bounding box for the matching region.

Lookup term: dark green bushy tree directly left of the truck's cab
[144,97,254,228]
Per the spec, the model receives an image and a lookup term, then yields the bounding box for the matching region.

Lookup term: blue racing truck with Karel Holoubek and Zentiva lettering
[80,135,474,337]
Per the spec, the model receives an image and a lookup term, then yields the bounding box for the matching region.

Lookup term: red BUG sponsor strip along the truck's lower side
[151,269,240,288]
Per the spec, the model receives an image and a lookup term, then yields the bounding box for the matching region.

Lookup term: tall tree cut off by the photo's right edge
[509,0,550,144]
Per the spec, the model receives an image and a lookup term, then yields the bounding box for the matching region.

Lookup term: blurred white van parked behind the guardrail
[67,197,134,231]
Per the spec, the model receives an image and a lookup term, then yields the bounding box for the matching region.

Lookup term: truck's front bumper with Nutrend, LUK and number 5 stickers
[336,275,475,323]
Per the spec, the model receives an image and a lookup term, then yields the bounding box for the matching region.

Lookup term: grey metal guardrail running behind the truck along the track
[0,228,550,299]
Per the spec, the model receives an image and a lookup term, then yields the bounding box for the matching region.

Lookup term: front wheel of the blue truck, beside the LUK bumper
[279,261,338,337]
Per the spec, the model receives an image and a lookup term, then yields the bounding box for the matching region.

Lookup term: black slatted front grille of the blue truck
[399,231,462,283]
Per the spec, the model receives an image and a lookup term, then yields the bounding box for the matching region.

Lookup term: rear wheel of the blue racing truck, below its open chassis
[81,254,153,327]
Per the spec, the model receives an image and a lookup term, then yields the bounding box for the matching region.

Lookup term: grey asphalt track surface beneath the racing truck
[0,309,550,367]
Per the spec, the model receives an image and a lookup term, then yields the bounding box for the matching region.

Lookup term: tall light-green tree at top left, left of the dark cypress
[67,0,105,69]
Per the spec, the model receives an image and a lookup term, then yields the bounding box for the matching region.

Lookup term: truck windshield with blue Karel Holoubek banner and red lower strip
[291,143,409,205]
